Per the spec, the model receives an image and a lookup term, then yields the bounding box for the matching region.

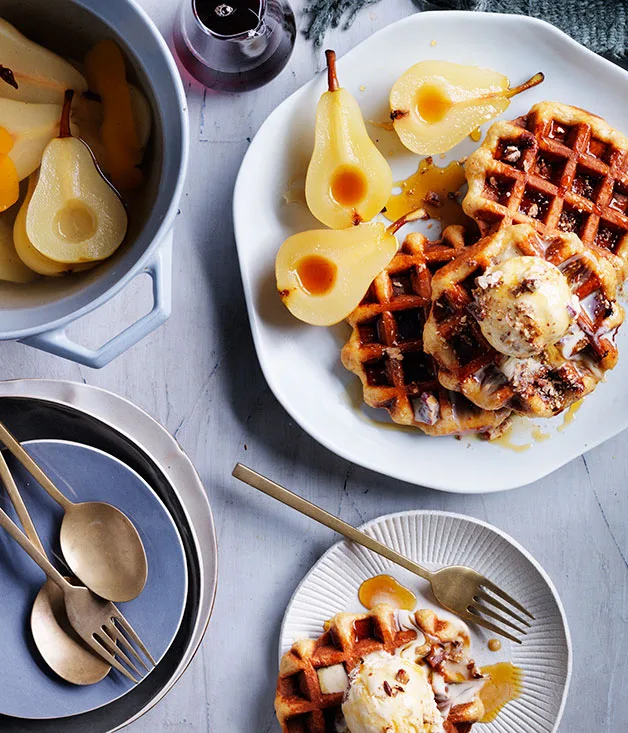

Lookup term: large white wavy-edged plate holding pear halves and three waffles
[234,11,628,493]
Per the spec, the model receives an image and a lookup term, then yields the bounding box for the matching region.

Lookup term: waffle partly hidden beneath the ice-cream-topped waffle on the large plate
[342,226,509,435]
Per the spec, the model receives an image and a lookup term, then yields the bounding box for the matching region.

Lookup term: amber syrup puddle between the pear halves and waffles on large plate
[384,157,471,227]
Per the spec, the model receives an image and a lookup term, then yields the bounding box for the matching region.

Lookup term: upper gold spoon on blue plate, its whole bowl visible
[0,422,148,603]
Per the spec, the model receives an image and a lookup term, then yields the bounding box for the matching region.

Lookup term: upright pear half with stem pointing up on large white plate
[305,51,392,229]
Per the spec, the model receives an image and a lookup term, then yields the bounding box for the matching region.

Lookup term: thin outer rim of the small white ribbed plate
[278,509,573,733]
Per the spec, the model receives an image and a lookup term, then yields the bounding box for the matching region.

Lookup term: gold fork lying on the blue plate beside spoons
[0,466,156,683]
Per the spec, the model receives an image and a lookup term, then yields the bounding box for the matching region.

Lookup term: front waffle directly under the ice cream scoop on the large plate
[424,224,624,417]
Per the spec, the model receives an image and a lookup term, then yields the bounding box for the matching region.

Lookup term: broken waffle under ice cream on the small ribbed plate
[275,604,483,733]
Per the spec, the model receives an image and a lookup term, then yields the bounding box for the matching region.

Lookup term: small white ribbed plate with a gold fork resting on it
[279,511,572,733]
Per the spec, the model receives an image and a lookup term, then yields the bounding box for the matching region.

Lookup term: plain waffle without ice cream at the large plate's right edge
[462,102,628,269]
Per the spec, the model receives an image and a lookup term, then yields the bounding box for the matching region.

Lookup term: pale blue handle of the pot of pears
[21,230,172,369]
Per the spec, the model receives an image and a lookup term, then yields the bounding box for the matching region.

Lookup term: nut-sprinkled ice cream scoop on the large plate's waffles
[474,257,579,358]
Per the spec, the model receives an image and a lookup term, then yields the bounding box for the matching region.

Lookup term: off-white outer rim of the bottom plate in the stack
[0,377,218,733]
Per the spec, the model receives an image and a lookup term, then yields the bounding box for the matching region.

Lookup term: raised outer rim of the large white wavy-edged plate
[232,10,628,494]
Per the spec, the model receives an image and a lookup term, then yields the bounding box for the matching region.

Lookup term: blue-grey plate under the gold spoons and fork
[0,440,188,718]
